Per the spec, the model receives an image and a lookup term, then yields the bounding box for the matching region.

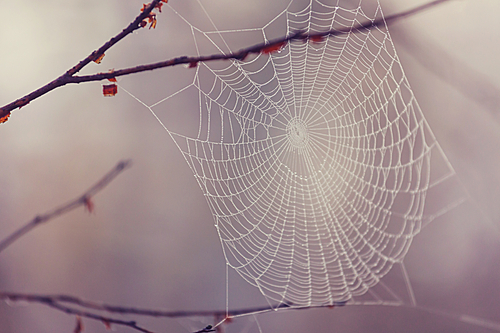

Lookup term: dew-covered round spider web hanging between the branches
[121,0,468,312]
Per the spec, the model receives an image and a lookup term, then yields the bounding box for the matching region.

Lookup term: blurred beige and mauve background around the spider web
[0,0,500,333]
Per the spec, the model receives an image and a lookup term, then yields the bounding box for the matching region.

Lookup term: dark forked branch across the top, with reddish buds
[0,0,451,119]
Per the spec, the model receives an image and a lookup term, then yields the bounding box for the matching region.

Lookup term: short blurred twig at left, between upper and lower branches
[0,160,131,252]
